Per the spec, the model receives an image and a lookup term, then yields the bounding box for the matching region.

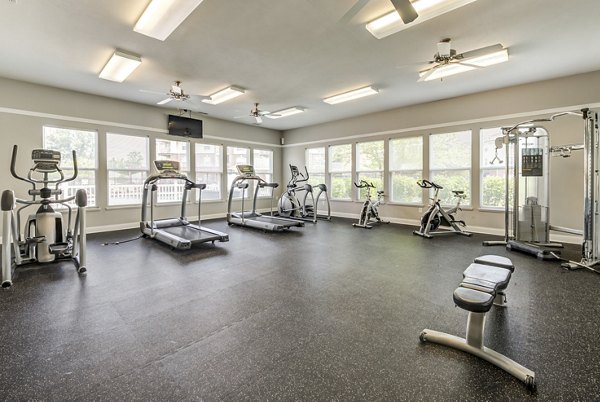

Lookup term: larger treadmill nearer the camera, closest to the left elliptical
[140,160,229,250]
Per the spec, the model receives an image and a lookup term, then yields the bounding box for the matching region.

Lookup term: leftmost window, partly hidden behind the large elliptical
[42,126,98,207]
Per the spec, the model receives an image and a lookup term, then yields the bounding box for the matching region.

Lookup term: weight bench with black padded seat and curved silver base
[419,255,536,391]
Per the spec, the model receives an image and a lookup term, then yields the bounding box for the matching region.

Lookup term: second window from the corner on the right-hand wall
[329,144,352,200]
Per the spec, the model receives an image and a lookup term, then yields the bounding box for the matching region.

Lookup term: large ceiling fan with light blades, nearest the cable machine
[418,38,505,82]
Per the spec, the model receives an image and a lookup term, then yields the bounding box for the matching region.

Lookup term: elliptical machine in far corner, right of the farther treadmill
[277,164,331,223]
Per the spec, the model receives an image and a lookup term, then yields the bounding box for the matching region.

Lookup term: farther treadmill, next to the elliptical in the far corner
[227,165,304,232]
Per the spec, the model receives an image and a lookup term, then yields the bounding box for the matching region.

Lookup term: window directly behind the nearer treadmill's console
[156,139,190,202]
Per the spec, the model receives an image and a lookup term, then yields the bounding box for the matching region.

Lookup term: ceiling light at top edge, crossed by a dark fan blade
[366,0,476,39]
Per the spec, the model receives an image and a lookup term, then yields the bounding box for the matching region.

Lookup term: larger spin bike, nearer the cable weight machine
[413,179,471,238]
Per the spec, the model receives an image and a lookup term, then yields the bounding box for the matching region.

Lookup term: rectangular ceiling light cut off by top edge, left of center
[133,0,203,40]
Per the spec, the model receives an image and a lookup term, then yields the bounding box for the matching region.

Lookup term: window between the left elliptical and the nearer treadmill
[106,133,150,205]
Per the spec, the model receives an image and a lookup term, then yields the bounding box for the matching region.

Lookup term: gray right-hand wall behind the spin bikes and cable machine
[283,71,600,239]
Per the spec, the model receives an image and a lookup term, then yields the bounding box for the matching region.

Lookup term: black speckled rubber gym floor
[0,218,600,401]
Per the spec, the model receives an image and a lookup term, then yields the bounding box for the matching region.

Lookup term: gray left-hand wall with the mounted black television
[0,78,282,231]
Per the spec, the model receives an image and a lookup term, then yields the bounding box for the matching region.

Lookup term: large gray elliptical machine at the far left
[1,145,87,288]
